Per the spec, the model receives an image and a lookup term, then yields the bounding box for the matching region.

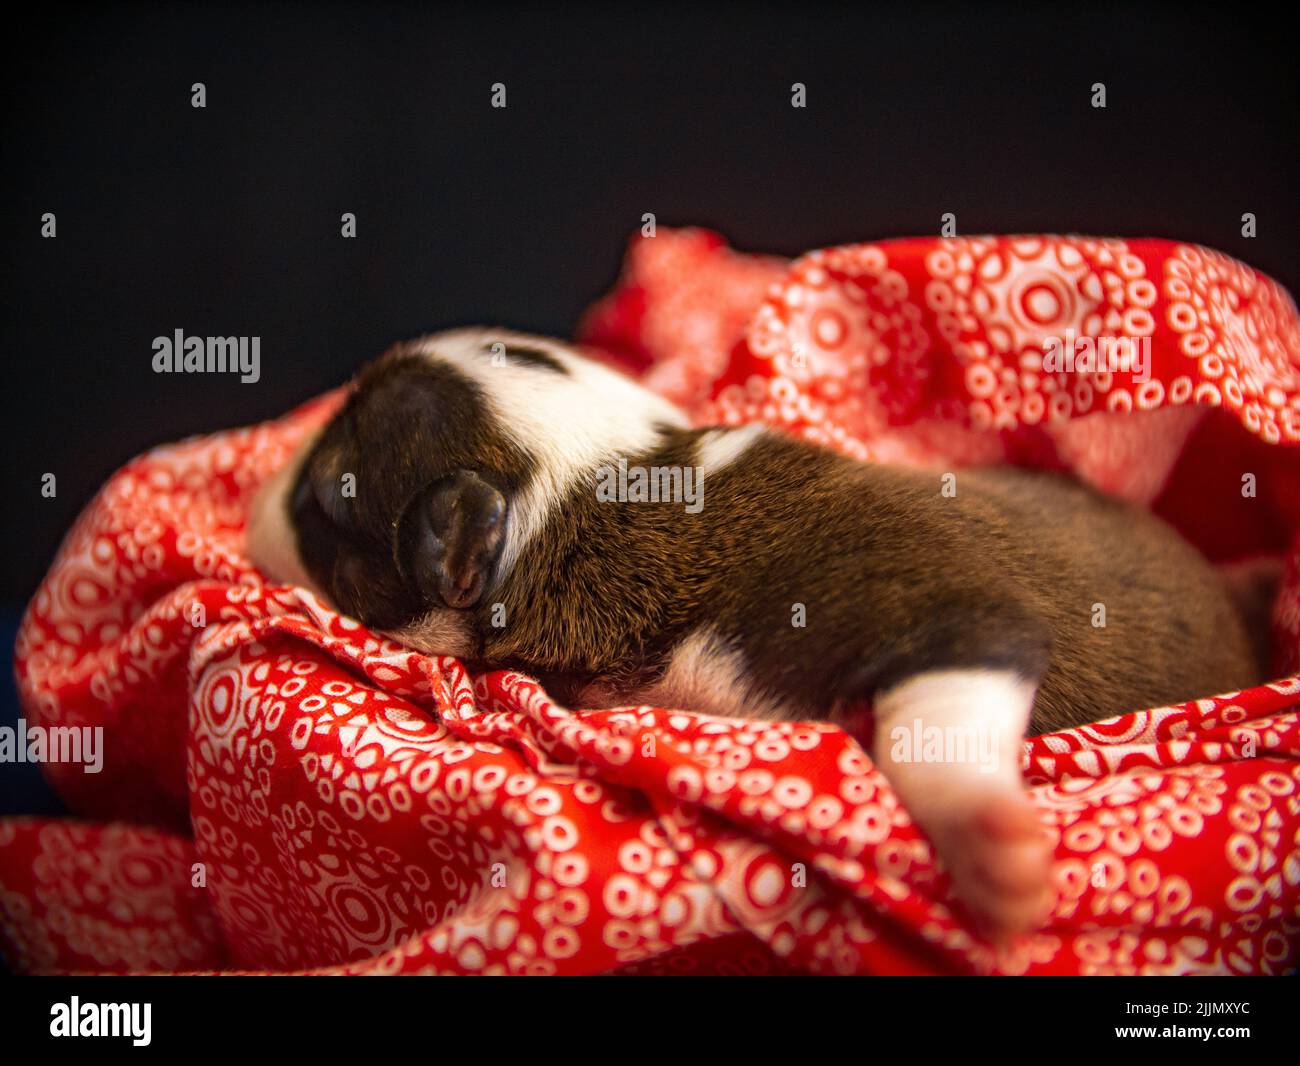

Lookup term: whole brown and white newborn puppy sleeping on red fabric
[248,330,1258,937]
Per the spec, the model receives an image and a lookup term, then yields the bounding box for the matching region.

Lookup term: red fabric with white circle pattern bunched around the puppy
[0,230,1300,974]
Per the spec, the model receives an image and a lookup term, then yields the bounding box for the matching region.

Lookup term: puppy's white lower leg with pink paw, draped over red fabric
[872,667,1053,939]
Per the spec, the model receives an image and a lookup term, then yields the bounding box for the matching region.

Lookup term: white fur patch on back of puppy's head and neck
[419,329,689,581]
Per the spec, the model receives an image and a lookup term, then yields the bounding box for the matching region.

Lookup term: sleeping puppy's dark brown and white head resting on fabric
[248,329,685,642]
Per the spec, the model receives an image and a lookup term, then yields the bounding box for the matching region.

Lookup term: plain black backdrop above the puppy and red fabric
[0,3,1300,610]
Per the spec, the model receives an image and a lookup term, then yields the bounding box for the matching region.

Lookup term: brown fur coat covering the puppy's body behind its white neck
[481,423,1257,732]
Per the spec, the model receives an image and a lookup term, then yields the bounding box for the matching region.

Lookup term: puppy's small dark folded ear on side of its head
[394,469,506,608]
